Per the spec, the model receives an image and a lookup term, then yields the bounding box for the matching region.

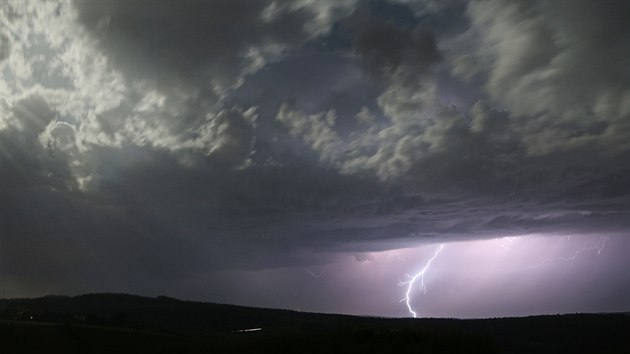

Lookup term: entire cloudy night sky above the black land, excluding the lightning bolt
[0,0,630,317]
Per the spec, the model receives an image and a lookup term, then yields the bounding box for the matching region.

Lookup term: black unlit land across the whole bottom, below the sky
[0,294,630,354]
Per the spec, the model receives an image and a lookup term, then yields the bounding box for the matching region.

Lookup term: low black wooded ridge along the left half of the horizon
[0,294,339,331]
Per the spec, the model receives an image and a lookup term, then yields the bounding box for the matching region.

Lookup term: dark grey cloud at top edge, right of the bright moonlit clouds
[77,1,354,95]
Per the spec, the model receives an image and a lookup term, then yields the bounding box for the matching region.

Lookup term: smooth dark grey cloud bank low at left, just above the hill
[1,137,388,291]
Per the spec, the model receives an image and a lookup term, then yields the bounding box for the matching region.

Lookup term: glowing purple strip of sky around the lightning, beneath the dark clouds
[164,235,630,318]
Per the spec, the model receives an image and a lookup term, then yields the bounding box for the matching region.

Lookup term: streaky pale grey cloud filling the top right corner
[451,1,630,154]
